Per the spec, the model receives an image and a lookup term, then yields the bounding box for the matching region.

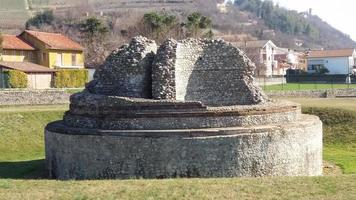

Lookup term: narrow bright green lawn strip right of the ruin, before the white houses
[261,83,356,91]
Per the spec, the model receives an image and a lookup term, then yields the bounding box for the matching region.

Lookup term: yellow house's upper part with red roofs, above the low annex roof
[0,30,84,69]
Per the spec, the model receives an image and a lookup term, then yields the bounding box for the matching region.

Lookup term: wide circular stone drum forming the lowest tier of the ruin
[45,115,322,179]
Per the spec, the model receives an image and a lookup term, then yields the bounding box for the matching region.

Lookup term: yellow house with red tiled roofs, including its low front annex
[0,30,84,89]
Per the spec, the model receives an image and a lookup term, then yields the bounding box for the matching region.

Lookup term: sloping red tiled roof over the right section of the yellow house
[22,30,84,51]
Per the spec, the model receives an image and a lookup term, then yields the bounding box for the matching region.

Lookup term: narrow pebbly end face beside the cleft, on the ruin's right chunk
[152,39,178,99]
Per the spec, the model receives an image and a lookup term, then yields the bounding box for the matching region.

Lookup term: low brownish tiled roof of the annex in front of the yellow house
[0,62,56,73]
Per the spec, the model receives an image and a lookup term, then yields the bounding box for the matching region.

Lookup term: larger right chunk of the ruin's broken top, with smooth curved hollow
[152,39,267,106]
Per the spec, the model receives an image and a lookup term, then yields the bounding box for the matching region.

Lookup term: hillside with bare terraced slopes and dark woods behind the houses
[0,0,356,49]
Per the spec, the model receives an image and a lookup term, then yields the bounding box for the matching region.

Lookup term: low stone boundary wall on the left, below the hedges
[0,90,70,105]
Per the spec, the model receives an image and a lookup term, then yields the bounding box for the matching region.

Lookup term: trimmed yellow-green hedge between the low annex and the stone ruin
[54,69,88,88]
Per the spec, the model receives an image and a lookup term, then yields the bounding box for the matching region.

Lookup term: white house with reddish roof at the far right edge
[307,49,356,74]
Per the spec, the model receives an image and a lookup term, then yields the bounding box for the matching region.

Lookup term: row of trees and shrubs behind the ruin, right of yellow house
[25,10,213,66]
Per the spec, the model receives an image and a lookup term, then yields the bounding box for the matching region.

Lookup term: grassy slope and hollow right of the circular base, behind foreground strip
[290,98,356,174]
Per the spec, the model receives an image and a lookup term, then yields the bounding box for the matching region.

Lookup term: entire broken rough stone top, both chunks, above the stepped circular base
[82,36,268,106]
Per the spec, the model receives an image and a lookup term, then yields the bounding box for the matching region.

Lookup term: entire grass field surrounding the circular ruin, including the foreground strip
[0,99,356,199]
